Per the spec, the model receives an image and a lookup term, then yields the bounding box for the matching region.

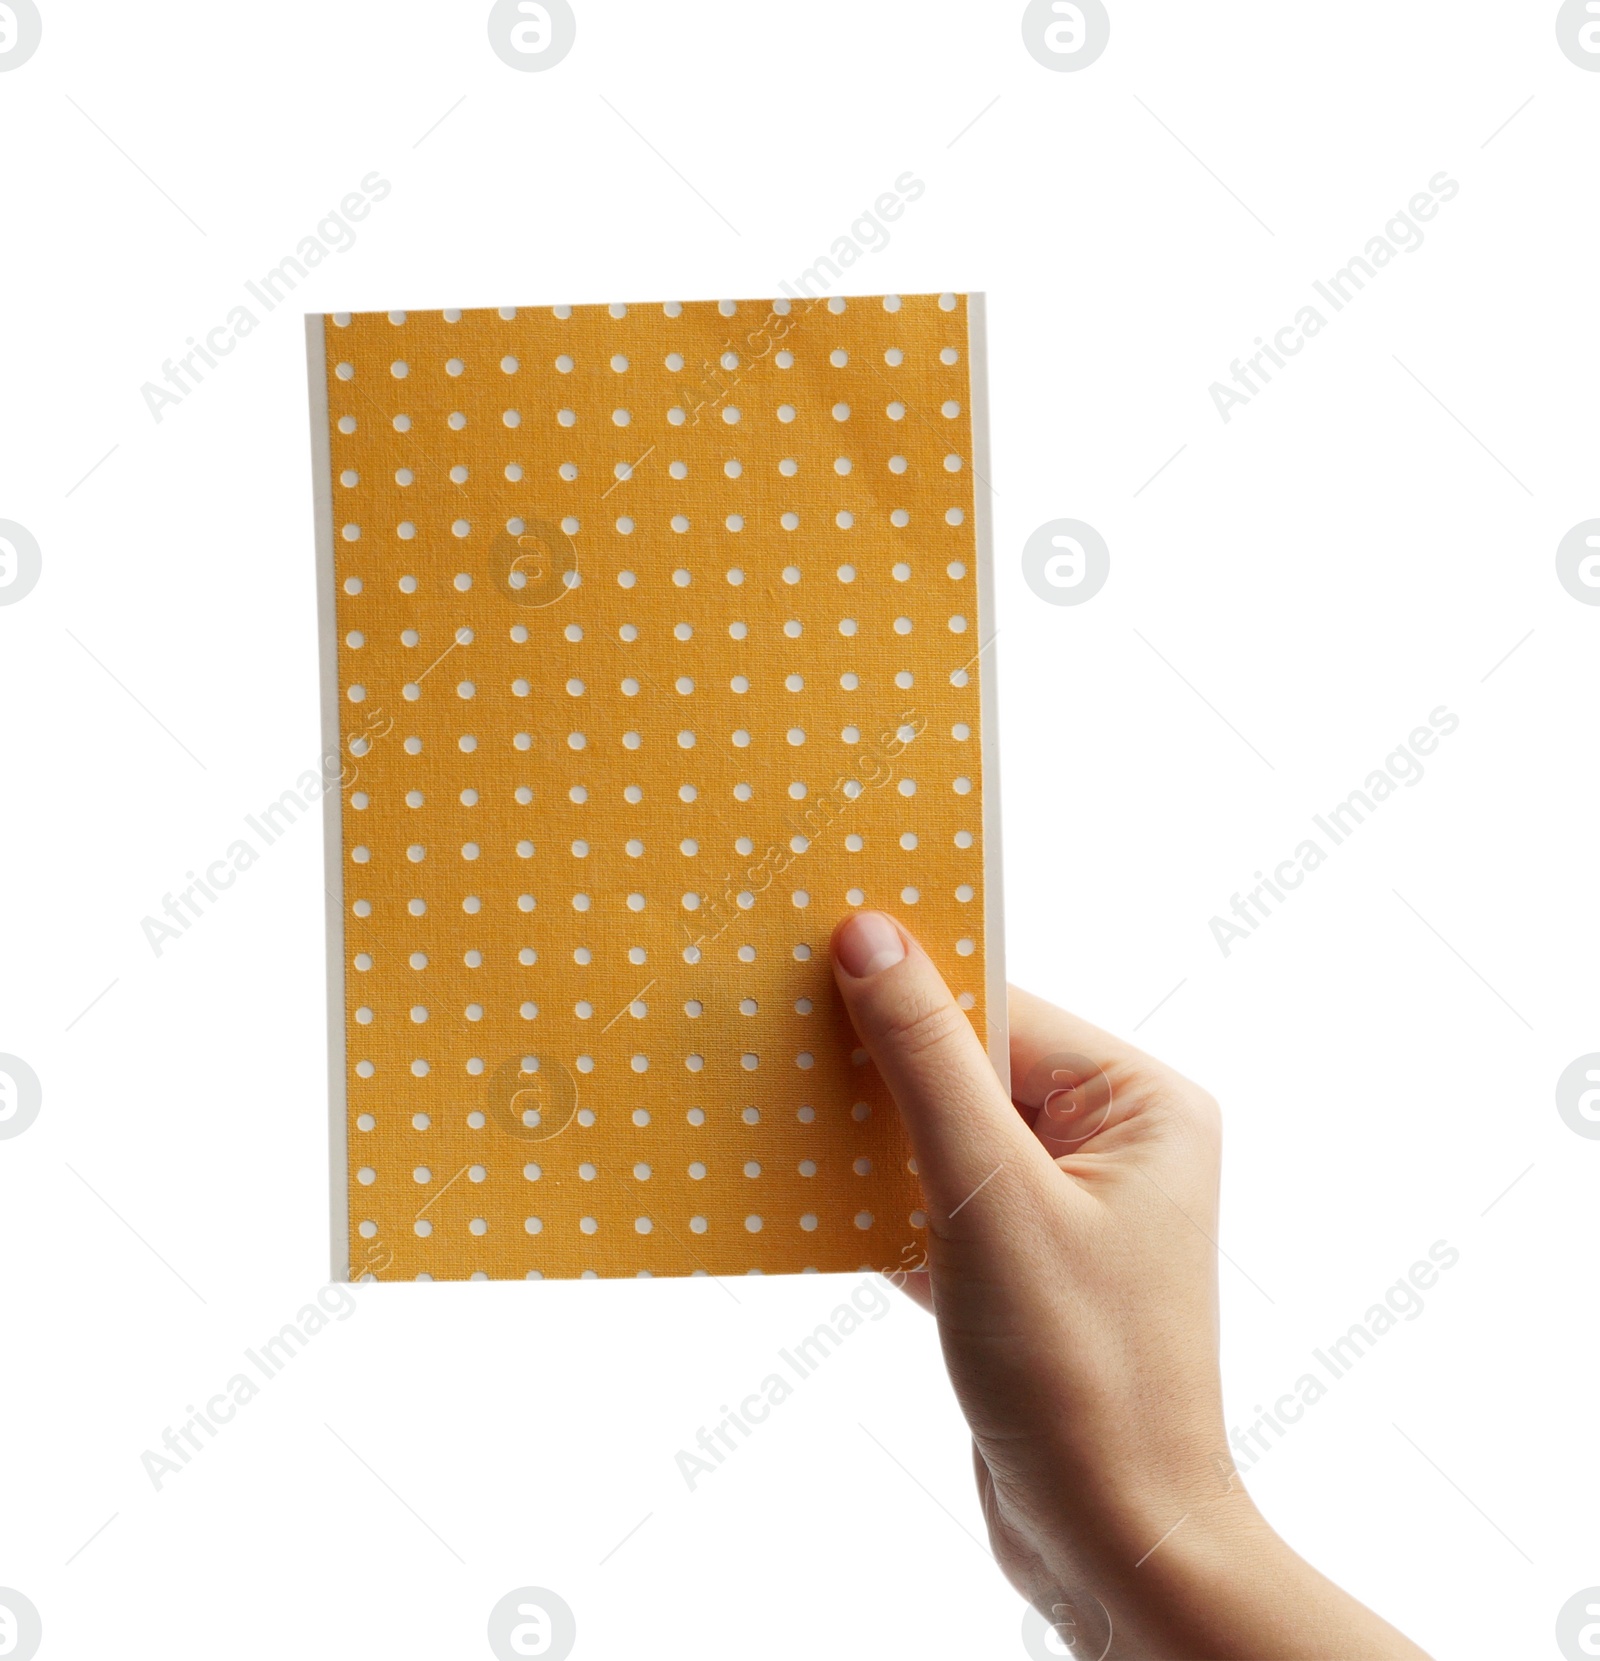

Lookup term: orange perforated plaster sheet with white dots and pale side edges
[307,294,1004,1279]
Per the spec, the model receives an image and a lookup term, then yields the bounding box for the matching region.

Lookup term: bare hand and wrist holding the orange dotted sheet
[832,912,1427,1661]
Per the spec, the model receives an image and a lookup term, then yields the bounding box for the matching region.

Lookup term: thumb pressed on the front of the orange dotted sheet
[831,912,1053,1236]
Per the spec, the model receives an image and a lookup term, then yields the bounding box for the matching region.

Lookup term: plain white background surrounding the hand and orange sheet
[0,0,1600,1658]
